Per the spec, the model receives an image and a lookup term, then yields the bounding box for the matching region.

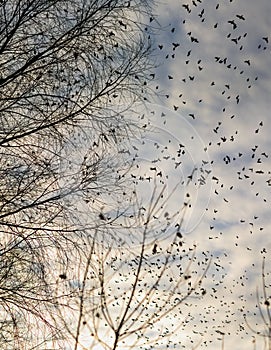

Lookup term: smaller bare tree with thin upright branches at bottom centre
[59,188,210,350]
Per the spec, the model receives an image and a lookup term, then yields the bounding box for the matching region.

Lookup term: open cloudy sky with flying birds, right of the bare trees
[129,0,271,350]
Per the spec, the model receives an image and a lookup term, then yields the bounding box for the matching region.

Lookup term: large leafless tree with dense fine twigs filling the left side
[0,0,157,349]
